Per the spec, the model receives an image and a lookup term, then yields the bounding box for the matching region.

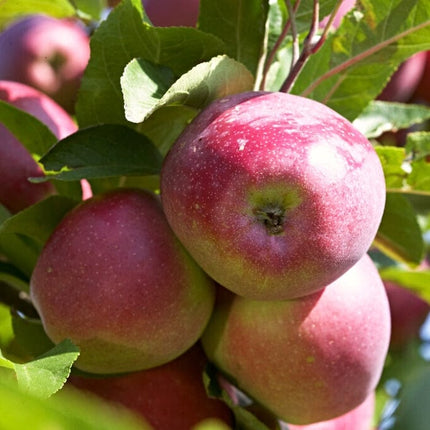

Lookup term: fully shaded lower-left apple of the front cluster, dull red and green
[30,189,215,373]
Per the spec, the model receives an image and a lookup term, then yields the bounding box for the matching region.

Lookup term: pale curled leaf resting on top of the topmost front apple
[122,55,254,122]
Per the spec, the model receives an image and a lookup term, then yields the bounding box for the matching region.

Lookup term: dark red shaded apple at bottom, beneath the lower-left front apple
[68,343,233,430]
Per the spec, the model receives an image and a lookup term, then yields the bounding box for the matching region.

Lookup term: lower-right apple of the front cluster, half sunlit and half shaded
[202,255,390,425]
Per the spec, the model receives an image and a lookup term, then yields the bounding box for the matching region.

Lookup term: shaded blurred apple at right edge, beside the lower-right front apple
[384,281,430,350]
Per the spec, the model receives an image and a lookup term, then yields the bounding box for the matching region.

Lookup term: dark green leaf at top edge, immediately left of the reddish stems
[199,0,268,75]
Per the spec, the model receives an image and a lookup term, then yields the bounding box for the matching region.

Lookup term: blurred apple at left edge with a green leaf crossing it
[0,79,77,213]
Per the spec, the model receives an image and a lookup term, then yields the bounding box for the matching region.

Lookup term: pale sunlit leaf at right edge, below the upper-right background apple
[353,101,430,139]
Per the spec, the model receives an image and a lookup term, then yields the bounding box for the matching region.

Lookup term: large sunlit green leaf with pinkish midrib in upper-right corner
[292,0,430,121]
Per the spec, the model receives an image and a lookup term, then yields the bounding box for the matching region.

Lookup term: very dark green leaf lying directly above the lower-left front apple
[40,124,162,181]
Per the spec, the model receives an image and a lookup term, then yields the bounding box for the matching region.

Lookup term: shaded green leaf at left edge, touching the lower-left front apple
[0,195,77,249]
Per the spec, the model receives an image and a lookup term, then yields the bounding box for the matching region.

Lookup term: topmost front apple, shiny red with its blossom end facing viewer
[161,92,385,300]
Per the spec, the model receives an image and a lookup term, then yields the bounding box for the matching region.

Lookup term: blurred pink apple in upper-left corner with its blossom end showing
[0,15,90,113]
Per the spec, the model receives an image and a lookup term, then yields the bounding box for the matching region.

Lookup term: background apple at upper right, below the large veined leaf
[378,51,426,103]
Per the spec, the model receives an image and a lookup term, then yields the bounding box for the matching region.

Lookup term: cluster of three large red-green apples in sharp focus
[26,86,390,428]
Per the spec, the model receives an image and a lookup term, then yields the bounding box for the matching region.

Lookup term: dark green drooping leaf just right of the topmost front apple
[375,193,424,267]
